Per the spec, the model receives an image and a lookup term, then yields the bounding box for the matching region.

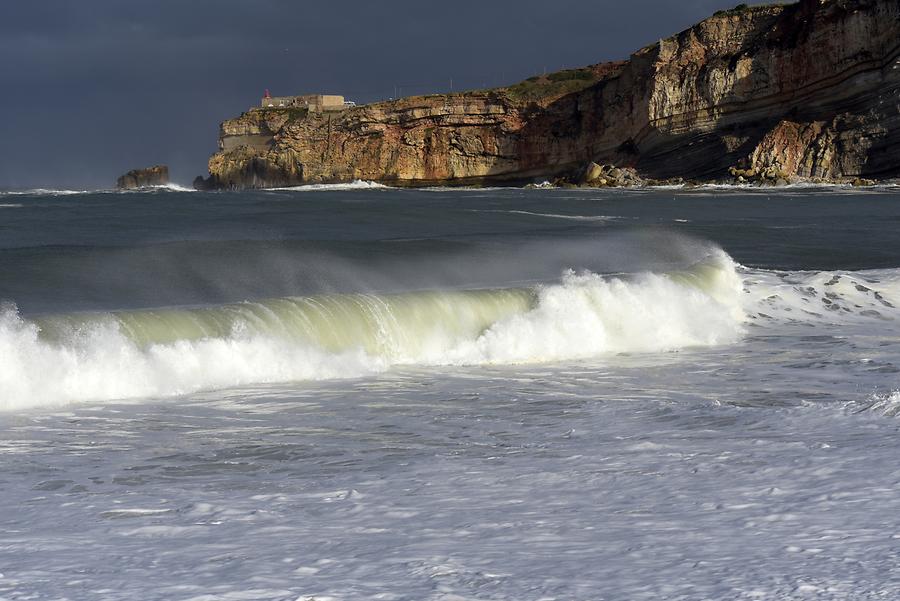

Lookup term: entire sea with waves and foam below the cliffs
[0,182,900,601]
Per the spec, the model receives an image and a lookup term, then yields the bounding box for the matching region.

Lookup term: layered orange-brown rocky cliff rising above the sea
[202,0,900,187]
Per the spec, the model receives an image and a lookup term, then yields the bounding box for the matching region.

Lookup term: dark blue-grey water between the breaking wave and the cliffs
[0,188,900,314]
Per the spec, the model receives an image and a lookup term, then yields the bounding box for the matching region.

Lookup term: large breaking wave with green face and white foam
[0,251,744,409]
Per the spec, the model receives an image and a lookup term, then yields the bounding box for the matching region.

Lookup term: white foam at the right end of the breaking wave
[449,258,743,363]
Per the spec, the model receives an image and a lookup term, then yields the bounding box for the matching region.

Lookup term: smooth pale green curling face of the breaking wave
[35,289,537,360]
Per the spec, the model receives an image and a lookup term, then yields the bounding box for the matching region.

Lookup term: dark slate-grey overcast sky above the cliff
[0,0,737,189]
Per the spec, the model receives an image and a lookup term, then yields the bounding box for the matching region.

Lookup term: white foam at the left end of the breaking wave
[0,310,381,409]
